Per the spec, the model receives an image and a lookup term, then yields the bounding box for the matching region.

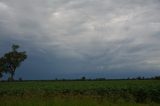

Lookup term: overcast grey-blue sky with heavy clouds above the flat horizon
[0,0,160,79]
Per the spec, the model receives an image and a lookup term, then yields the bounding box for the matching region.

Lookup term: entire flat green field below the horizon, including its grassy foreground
[0,80,160,106]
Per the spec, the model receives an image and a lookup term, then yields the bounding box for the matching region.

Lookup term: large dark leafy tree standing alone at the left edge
[0,44,27,80]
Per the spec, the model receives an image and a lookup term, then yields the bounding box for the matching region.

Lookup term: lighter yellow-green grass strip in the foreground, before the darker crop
[0,95,159,106]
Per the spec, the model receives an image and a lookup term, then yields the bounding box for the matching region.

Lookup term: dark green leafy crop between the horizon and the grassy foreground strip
[0,80,160,103]
